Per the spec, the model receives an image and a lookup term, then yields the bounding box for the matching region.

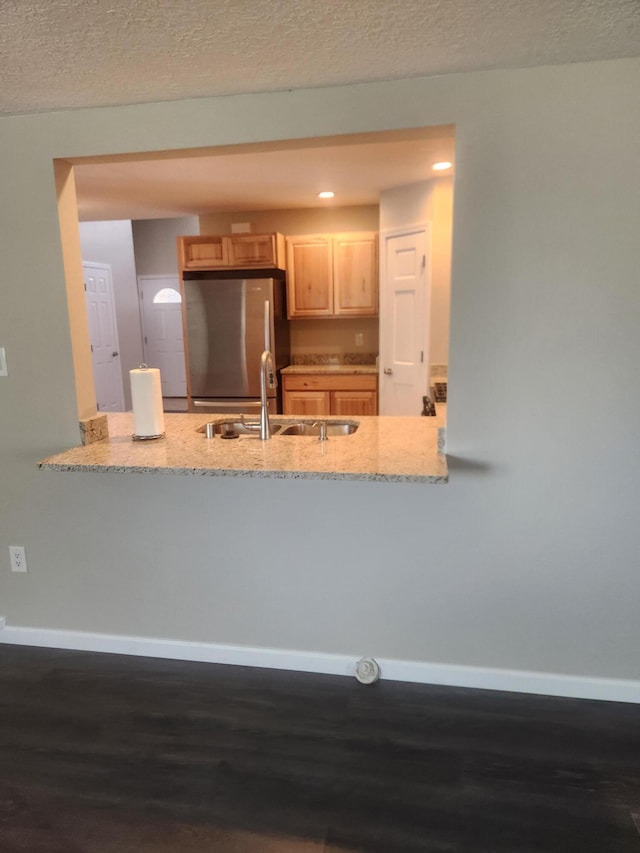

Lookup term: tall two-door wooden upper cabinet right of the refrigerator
[287,232,378,318]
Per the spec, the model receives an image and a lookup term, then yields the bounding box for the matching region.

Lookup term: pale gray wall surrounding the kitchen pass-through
[0,60,640,678]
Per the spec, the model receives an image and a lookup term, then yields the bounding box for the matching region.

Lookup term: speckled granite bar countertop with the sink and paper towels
[39,409,448,483]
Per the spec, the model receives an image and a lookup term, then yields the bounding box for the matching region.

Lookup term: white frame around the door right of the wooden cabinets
[378,221,432,412]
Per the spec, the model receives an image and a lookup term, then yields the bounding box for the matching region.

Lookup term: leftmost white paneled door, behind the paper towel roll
[82,263,124,412]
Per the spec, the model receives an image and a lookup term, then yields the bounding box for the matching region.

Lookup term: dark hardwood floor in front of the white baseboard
[0,645,640,853]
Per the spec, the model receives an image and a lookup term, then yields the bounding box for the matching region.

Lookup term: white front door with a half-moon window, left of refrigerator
[138,275,187,397]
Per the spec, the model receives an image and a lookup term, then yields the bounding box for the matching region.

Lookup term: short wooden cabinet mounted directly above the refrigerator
[178,234,286,270]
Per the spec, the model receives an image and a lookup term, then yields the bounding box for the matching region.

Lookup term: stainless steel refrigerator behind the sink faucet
[182,270,291,413]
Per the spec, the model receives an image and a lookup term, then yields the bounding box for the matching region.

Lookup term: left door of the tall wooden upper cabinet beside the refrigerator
[287,235,333,317]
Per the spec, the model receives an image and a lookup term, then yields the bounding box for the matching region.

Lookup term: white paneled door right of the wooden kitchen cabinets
[380,227,429,415]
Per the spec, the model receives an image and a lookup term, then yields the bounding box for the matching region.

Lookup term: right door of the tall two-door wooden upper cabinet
[333,234,378,317]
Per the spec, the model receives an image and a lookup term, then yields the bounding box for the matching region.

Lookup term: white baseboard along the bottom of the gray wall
[0,619,640,704]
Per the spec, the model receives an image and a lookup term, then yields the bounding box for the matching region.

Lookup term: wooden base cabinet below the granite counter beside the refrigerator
[282,373,378,417]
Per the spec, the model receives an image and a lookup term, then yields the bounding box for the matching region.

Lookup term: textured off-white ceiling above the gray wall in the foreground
[0,0,640,115]
